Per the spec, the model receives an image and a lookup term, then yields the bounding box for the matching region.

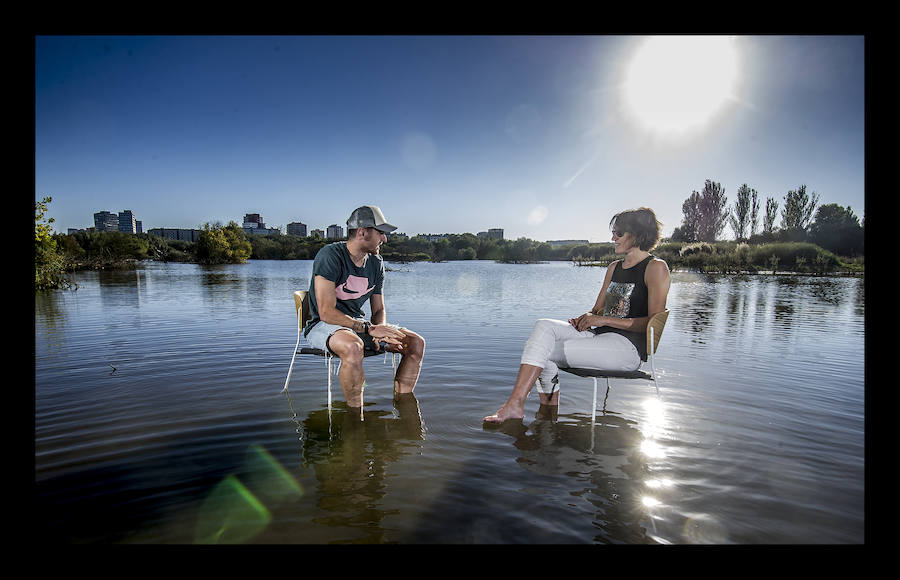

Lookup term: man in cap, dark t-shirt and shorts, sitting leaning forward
[304,205,425,407]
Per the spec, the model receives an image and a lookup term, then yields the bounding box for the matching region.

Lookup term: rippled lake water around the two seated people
[34,261,866,544]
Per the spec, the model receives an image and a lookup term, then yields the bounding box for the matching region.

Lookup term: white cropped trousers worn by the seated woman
[522,318,641,395]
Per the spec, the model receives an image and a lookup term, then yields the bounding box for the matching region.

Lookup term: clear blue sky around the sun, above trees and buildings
[35,36,865,242]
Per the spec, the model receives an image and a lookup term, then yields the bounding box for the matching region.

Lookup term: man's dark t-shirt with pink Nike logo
[303,242,384,335]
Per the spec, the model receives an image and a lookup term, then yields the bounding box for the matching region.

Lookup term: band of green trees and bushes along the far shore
[34,190,864,289]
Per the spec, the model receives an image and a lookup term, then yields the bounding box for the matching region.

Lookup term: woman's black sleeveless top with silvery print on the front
[594,254,653,361]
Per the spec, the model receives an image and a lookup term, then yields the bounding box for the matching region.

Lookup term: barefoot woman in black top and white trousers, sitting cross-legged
[484,207,669,423]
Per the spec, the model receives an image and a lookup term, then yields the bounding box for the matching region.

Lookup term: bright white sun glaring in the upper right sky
[624,36,738,133]
